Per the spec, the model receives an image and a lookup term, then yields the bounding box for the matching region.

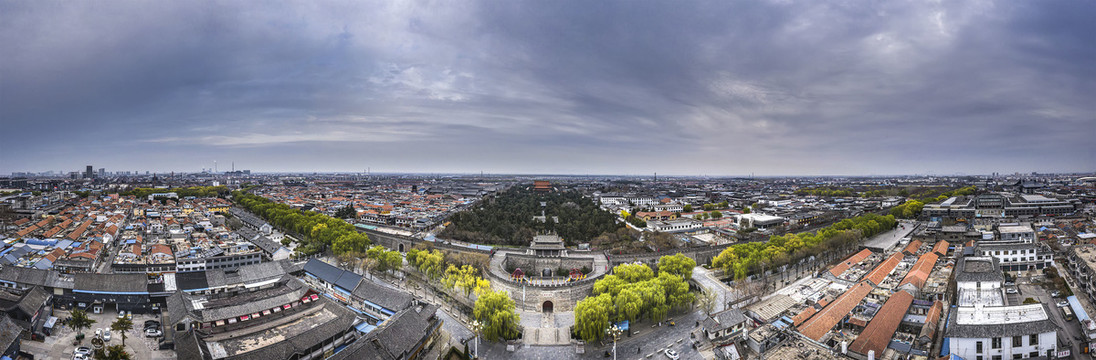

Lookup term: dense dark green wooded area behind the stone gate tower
[439,187,624,245]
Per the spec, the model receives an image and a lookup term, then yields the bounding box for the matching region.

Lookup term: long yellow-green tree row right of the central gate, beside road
[712,213,898,280]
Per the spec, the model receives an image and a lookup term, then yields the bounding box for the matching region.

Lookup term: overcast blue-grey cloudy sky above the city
[0,0,1096,175]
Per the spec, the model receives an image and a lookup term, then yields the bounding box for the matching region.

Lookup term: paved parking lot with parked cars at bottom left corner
[22,310,175,359]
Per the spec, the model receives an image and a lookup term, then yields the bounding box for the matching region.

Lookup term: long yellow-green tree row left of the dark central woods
[232,191,372,256]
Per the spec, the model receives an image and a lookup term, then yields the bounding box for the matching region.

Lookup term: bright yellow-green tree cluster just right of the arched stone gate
[574,254,696,341]
